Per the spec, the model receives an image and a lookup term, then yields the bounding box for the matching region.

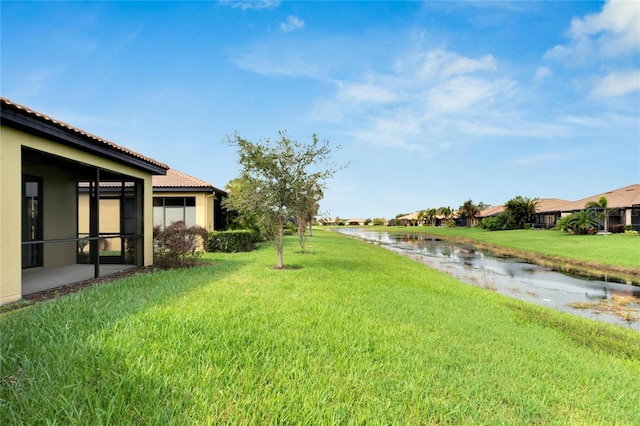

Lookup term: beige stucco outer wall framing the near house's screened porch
[0,126,158,304]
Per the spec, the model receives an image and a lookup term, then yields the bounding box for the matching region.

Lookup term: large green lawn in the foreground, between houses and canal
[0,231,640,425]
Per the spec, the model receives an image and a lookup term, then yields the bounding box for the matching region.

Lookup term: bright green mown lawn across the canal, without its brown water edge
[368,226,640,268]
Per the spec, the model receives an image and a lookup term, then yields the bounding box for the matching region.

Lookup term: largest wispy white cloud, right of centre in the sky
[314,49,516,153]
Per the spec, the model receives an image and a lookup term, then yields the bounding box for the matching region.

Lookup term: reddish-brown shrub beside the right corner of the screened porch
[153,221,207,268]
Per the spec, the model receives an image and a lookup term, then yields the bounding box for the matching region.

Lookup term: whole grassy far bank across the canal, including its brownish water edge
[370,226,640,284]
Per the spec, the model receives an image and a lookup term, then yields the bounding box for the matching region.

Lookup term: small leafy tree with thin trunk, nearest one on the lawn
[224,131,337,269]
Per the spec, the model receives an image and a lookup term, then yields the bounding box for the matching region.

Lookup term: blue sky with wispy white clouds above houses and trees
[0,1,640,218]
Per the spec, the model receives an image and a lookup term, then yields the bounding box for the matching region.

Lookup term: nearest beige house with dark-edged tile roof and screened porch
[0,98,169,304]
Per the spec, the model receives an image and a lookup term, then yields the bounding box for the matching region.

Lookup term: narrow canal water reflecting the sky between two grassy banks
[338,228,640,330]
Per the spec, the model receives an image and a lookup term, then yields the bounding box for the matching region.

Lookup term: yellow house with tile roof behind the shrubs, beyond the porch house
[153,169,228,231]
